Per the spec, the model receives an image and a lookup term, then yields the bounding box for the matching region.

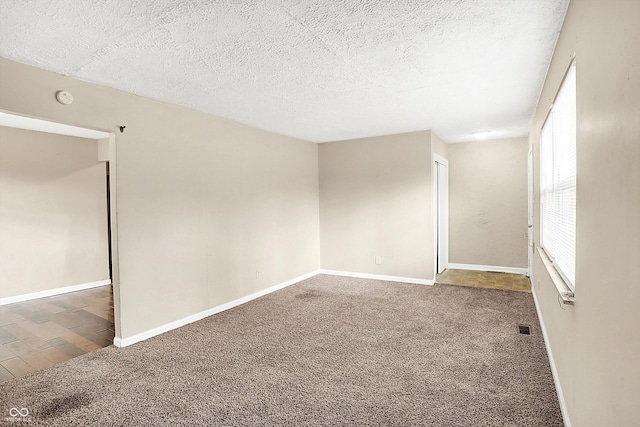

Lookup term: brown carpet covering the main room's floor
[0,275,562,426]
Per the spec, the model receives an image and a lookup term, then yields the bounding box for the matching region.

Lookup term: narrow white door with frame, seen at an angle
[433,154,449,275]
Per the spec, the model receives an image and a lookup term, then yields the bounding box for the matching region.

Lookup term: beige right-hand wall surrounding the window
[530,0,640,427]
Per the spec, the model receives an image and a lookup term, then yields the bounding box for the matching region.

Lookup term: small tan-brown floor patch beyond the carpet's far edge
[436,269,531,292]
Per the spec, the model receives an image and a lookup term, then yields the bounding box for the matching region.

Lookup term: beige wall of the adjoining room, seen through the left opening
[0,126,109,298]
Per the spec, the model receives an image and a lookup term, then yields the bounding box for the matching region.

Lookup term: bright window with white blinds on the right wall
[540,62,576,290]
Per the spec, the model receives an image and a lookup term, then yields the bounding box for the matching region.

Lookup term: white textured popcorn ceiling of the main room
[0,0,569,142]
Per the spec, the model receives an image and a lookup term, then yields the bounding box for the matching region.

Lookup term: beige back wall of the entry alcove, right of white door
[448,138,529,268]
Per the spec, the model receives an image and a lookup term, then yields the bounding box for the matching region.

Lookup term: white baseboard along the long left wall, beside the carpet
[113,270,320,347]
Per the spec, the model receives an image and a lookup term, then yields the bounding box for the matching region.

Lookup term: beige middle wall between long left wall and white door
[319,131,433,280]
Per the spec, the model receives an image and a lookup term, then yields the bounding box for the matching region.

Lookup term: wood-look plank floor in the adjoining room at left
[0,285,115,382]
